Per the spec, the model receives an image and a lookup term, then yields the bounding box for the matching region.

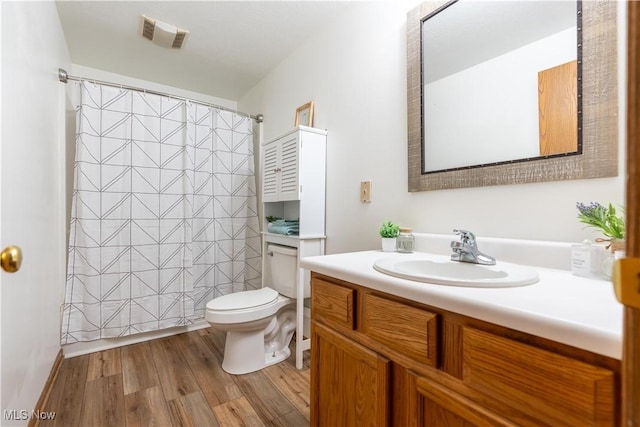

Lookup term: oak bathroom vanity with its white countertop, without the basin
[301,251,622,426]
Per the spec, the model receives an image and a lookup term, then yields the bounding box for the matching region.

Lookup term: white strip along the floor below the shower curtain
[62,319,211,358]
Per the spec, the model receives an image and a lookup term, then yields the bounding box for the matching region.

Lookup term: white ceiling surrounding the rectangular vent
[56,0,349,100]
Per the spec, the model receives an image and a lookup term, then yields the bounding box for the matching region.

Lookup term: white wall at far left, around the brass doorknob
[0,1,70,425]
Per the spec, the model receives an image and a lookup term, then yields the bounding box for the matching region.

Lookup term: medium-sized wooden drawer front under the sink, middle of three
[360,293,437,366]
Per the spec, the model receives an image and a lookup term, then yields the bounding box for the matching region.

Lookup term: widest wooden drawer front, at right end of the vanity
[462,327,616,426]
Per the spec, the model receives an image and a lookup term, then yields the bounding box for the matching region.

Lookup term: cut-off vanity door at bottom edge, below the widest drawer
[408,373,518,427]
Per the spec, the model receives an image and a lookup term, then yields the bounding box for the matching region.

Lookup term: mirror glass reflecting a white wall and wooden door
[421,0,582,173]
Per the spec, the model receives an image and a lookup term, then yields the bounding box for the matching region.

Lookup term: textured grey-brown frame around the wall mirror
[407,0,618,191]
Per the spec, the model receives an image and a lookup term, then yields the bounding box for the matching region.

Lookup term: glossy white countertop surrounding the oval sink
[300,251,623,359]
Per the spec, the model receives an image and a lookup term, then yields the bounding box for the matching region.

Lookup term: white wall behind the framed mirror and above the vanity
[239,0,625,253]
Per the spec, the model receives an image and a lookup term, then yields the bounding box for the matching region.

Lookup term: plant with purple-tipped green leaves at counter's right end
[576,202,624,252]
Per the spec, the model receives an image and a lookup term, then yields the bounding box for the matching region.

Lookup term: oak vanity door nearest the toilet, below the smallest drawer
[311,322,390,427]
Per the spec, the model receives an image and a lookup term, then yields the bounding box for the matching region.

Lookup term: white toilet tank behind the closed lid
[264,243,309,298]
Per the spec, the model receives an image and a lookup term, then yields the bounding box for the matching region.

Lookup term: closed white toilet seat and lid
[205,287,293,325]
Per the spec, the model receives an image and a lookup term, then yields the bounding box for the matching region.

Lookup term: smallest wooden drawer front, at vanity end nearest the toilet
[311,277,356,329]
